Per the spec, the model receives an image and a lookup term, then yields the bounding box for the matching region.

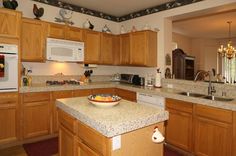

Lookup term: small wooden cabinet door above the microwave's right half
[65,26,83,41]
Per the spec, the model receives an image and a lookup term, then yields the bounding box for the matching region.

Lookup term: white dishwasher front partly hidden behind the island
[137,93,165,110]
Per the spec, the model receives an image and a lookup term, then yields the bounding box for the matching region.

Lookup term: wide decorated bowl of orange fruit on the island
[88,94,121,108]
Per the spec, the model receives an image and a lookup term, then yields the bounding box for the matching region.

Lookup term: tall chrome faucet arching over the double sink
[194,70,216,96]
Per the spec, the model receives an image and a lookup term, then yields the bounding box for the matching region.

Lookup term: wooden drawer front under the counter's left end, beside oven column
[23,92,50,102]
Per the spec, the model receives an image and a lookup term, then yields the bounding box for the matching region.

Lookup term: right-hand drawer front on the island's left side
[77,121,108,155]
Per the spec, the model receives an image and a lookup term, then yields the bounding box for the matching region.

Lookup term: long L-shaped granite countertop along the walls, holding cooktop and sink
[20,82,236,111]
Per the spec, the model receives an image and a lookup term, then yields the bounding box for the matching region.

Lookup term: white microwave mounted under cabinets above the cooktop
[47,38,84,62]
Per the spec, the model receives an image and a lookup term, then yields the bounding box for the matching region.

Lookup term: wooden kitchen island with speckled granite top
[56,97,168,156]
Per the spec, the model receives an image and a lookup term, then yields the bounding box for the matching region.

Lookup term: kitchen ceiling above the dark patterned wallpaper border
[61,0,175,17]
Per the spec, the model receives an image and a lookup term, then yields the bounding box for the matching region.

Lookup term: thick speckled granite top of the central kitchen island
[56,97,168,137]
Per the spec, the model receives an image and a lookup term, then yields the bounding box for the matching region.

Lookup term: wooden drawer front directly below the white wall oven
[0,93,18,104]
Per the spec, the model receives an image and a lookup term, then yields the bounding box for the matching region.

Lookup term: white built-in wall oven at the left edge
[0,43,18,92]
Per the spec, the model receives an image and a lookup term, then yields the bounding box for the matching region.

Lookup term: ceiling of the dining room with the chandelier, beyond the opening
[173,9,236,39]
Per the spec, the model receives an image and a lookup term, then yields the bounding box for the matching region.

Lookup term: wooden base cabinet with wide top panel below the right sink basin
[194,105,233,156]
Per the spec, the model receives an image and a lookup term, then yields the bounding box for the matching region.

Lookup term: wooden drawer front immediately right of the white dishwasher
[166,99,193,113]
